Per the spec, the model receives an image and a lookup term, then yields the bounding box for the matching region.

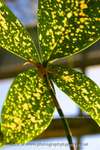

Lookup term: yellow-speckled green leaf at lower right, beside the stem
[51,66,100,126]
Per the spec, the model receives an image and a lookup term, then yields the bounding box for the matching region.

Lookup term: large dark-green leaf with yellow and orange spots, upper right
[38,0,100,59]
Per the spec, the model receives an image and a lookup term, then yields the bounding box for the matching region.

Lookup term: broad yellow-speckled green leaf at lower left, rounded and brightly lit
[1,70,54,144]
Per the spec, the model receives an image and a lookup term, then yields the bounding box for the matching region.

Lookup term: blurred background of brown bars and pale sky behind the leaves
[0,0,100,150]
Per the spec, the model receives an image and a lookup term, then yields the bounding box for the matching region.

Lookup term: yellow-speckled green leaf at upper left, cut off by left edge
[0,0,37,60]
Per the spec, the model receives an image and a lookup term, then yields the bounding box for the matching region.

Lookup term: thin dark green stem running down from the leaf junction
[47,77,75,150]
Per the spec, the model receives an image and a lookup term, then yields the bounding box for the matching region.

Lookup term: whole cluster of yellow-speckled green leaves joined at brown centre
[0,0,100,144]
